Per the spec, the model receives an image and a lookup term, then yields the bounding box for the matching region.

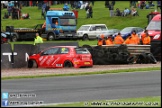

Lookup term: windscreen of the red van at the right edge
[146,21,161,30]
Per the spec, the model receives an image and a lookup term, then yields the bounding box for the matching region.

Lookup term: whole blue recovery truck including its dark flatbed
[5,10,78,41]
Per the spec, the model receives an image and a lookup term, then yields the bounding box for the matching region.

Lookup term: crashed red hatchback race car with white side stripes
[28,46,93,68]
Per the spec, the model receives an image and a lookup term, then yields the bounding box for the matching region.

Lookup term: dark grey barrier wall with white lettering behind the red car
[1,42,79,68]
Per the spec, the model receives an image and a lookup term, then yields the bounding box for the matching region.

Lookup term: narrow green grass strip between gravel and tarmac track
[1,67,161,80]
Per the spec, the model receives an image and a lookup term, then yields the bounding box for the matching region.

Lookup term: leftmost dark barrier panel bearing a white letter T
[1,44,12,69]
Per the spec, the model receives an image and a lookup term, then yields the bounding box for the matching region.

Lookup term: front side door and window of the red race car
[38,47,59,67]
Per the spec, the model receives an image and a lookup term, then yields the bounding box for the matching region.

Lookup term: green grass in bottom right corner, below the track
[42,96,161,107]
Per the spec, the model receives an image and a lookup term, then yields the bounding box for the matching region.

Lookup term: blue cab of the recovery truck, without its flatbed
[41,10,77,40]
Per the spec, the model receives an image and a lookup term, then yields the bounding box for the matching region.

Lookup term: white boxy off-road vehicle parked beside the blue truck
[77,24,108,40]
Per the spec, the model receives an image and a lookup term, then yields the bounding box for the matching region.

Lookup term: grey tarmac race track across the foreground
[1,71,161,104]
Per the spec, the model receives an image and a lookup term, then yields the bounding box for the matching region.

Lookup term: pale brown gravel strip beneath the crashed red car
[1,62,161,77]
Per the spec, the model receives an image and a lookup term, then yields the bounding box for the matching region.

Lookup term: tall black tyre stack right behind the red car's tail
[82,45,130,65]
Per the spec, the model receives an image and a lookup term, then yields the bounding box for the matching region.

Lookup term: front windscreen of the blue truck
[60,19,76,26]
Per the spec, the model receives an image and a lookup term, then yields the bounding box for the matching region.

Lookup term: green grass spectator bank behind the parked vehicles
[1,1,159,29]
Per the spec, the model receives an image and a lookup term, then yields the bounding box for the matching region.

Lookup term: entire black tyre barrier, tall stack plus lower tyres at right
[82,45,157,65]
